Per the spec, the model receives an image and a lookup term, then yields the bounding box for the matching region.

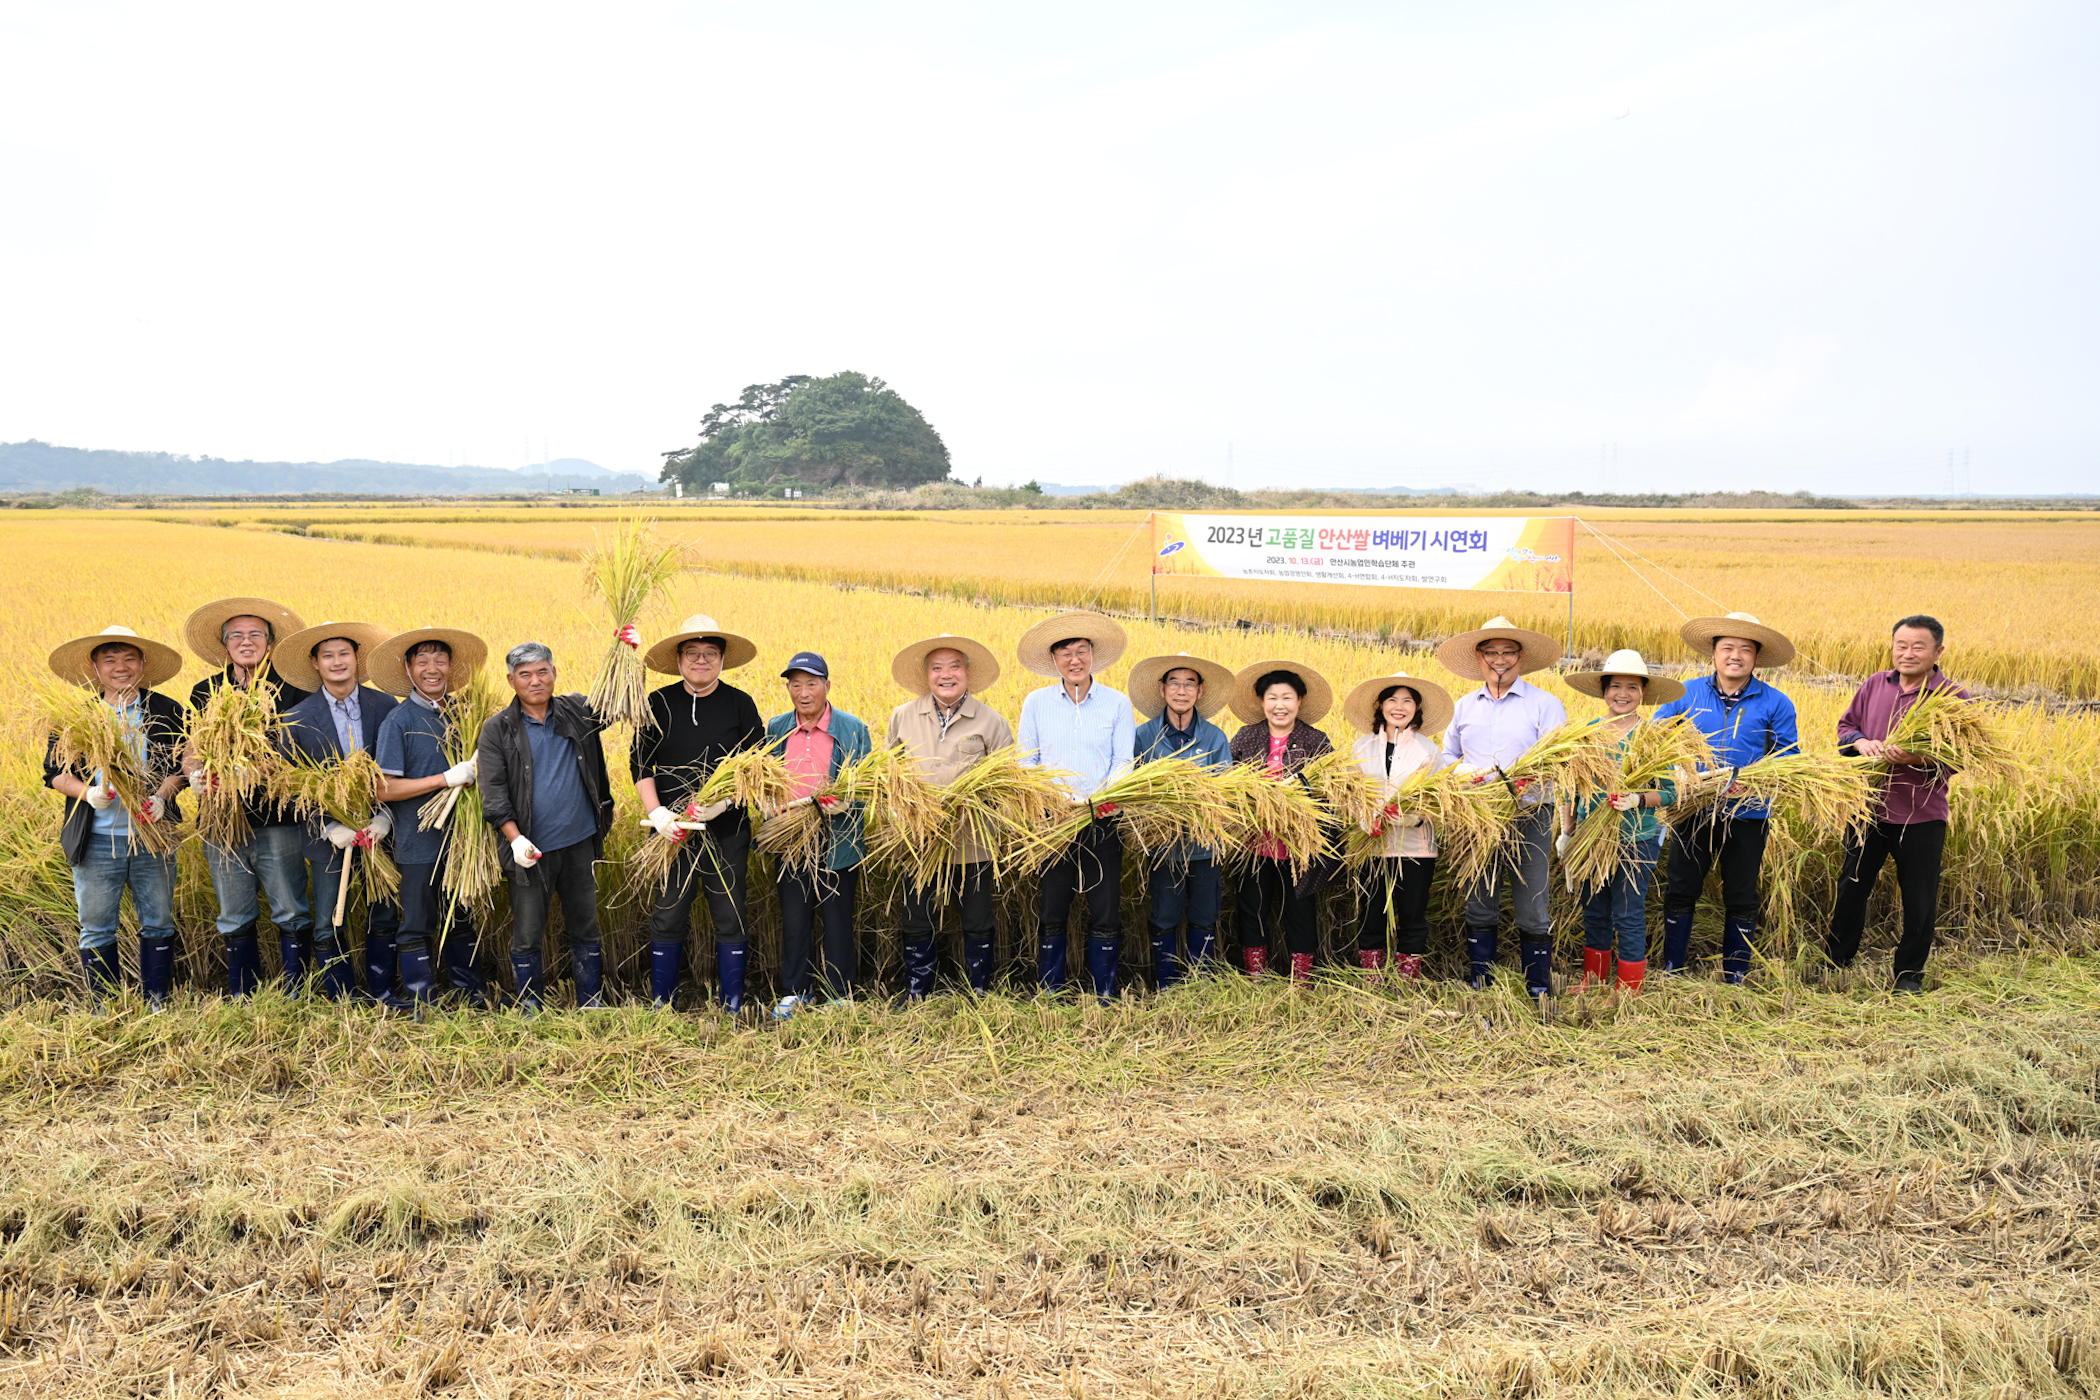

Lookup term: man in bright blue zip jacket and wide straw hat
[1655,613,1802,984]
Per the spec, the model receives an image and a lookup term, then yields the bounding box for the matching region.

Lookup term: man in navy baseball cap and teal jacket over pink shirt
[767,651,867,1020]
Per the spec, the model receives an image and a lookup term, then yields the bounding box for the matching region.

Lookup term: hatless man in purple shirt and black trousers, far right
[1825,615,1968,995]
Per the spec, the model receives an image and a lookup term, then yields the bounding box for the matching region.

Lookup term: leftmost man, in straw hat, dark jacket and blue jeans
[44,628,187,1010]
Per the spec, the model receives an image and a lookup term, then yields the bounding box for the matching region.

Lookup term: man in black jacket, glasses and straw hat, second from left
[183,598,313,997]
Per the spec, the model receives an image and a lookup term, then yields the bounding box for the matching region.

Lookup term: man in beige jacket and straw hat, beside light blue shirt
[886,634,1014,1001]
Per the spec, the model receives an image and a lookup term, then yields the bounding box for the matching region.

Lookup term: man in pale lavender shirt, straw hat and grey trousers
[1436,617,1569,997]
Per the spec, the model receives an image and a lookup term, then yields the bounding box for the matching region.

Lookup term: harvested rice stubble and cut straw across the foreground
[0,959,2100,1396]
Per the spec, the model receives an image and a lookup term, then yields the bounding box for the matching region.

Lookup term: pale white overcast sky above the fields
[0,0,2100,491]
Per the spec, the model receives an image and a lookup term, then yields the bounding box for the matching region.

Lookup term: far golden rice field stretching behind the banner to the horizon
[119,506,2100,699]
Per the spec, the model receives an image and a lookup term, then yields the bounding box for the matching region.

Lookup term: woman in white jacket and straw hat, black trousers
[1342,674,1451,982]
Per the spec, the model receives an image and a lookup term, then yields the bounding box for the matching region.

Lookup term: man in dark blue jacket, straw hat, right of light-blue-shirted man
[1130,651,1233,991]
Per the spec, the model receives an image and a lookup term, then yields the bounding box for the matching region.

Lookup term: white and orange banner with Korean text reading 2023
[1153,510,1575,594]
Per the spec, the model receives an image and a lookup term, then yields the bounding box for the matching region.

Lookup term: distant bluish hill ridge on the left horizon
[0,441,657,495]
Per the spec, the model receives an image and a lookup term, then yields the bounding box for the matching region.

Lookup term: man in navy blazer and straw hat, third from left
[273,621,401,1001]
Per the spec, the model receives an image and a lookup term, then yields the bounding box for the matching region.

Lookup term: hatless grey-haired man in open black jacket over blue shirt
[475,642,613,1012]
